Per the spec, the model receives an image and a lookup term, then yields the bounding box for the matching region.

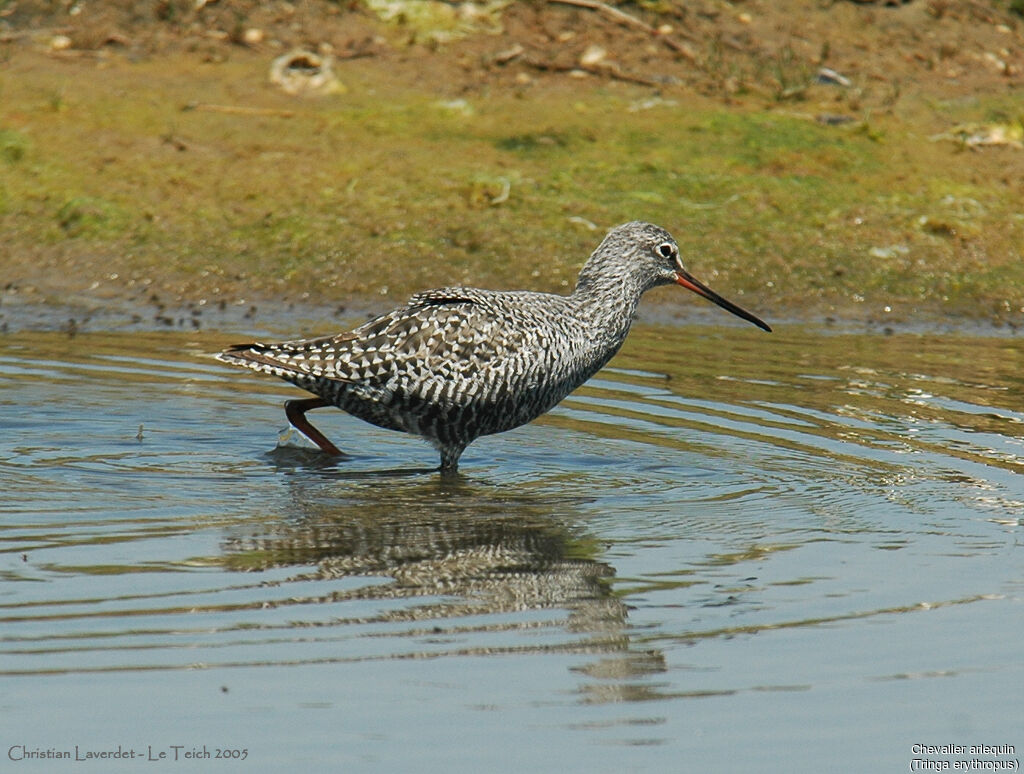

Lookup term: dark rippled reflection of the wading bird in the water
[224,469,665,701]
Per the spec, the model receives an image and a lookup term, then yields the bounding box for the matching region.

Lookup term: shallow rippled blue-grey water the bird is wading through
[0,327,1024,772]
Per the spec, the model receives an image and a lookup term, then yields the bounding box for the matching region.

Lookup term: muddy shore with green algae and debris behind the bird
[0,0,1024,330]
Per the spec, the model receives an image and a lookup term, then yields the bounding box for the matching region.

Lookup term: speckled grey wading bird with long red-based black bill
[217,222,770,469]
